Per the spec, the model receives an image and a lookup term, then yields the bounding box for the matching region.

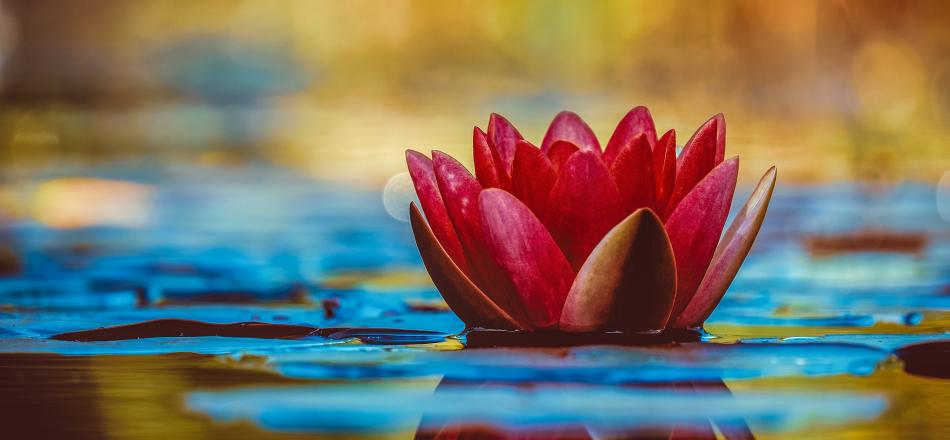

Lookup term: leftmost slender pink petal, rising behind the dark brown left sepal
[406,150,469,273]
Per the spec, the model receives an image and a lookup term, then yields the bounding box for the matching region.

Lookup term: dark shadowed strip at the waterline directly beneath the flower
[459,329,703,348]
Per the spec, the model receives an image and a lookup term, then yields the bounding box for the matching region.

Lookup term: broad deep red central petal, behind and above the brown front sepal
[545,150,623,269]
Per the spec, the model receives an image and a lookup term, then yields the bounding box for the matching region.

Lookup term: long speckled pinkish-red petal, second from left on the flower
[432,151,522,321]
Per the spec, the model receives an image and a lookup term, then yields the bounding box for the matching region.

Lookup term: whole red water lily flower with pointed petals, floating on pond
[406,107,775,332]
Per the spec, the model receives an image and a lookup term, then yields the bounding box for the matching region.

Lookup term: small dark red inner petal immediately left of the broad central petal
[512,141,557,218]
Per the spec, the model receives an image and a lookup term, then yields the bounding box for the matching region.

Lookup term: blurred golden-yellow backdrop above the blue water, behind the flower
[0,0,950,186]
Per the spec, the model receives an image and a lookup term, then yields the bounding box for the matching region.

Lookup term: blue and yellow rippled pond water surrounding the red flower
[0,167,950,438]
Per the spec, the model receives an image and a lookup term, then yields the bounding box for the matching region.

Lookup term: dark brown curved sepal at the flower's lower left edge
[409,203,527,329]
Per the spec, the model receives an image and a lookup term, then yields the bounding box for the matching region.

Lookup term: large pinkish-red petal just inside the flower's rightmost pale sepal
[666,157,739,317]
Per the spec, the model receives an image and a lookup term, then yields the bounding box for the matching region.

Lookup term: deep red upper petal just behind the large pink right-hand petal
[666,118,717,217]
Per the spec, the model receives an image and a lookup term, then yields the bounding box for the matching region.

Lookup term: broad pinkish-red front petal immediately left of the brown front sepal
[478,189,574,328]
